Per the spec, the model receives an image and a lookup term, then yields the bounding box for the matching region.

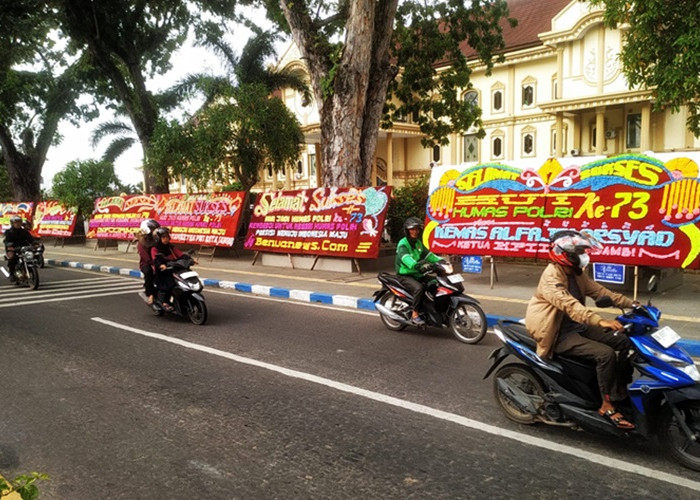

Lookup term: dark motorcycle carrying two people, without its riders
[139,254,207,325]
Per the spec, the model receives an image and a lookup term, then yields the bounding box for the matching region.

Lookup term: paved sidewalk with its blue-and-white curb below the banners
[45,239,700,356]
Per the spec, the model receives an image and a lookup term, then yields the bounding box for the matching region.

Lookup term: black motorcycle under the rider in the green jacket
[374,261,487,344]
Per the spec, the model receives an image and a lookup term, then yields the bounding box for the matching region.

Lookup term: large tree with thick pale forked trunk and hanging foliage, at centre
[248,0,514,186]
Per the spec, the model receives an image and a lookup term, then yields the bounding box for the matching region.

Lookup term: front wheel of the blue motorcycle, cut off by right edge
[659,401,700,471]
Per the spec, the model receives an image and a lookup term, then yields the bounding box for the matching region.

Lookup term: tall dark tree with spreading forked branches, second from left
[56,0,241,193]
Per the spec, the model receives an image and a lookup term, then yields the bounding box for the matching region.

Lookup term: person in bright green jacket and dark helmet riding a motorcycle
[394,217,442,325]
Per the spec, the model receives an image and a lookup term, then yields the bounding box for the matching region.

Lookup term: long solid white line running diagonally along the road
[91,317,700,491]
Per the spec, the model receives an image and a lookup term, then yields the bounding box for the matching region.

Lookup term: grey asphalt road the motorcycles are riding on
[0,268,700,499]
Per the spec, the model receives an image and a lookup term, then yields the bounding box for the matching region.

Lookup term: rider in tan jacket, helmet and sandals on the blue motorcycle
[525,230,638,429]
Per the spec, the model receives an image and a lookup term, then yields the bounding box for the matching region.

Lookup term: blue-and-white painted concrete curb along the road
[46,259,700,357]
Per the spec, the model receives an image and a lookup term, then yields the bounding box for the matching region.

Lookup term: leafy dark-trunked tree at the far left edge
[0,0,92,201]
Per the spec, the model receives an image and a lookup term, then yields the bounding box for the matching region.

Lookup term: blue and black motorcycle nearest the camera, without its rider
[484,278,700,471]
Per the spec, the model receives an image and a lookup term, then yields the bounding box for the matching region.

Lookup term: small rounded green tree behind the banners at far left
[52,160,128,218]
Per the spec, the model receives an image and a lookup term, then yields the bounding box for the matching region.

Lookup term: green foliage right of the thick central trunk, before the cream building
[382,0,516,147]
